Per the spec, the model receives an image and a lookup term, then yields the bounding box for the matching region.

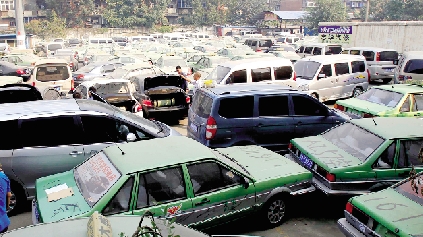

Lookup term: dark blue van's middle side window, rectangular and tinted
[259,96,289,116]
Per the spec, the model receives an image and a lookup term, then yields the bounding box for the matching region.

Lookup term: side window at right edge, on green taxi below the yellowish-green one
[398,140,423,168]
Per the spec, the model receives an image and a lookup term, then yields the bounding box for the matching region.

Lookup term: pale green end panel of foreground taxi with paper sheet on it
[35,170,91,223]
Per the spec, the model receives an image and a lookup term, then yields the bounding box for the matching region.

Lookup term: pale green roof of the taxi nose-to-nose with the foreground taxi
[351,117,423,139]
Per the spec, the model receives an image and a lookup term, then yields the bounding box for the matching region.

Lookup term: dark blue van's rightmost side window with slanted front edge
[292,96,327,116]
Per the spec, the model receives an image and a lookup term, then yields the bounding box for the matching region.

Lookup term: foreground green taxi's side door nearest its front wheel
[187,161,255,225]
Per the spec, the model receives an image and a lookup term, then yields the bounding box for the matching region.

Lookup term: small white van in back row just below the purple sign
[297,43,342,57]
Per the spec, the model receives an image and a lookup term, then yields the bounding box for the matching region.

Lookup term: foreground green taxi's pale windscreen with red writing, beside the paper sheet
[73,152,122,207]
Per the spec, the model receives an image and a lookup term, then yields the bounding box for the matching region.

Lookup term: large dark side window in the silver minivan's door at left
[20,116,79,147]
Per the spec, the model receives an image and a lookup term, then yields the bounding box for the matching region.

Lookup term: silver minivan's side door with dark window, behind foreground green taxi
[12,115,85,187]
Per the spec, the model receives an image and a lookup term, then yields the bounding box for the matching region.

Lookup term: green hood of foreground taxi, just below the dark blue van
[216,146,312,181]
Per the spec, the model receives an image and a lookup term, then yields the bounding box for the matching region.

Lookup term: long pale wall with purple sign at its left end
[319,21,423,53]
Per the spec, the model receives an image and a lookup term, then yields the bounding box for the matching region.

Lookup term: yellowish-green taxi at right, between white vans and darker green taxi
[334,84,423,118]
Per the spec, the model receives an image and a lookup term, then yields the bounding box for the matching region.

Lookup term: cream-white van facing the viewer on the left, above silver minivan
[26,58,74,100]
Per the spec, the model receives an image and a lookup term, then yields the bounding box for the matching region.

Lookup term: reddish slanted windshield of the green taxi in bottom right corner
[395,173,423,205]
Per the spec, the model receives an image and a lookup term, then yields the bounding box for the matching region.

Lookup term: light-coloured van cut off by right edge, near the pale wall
[394,51,423,84]
